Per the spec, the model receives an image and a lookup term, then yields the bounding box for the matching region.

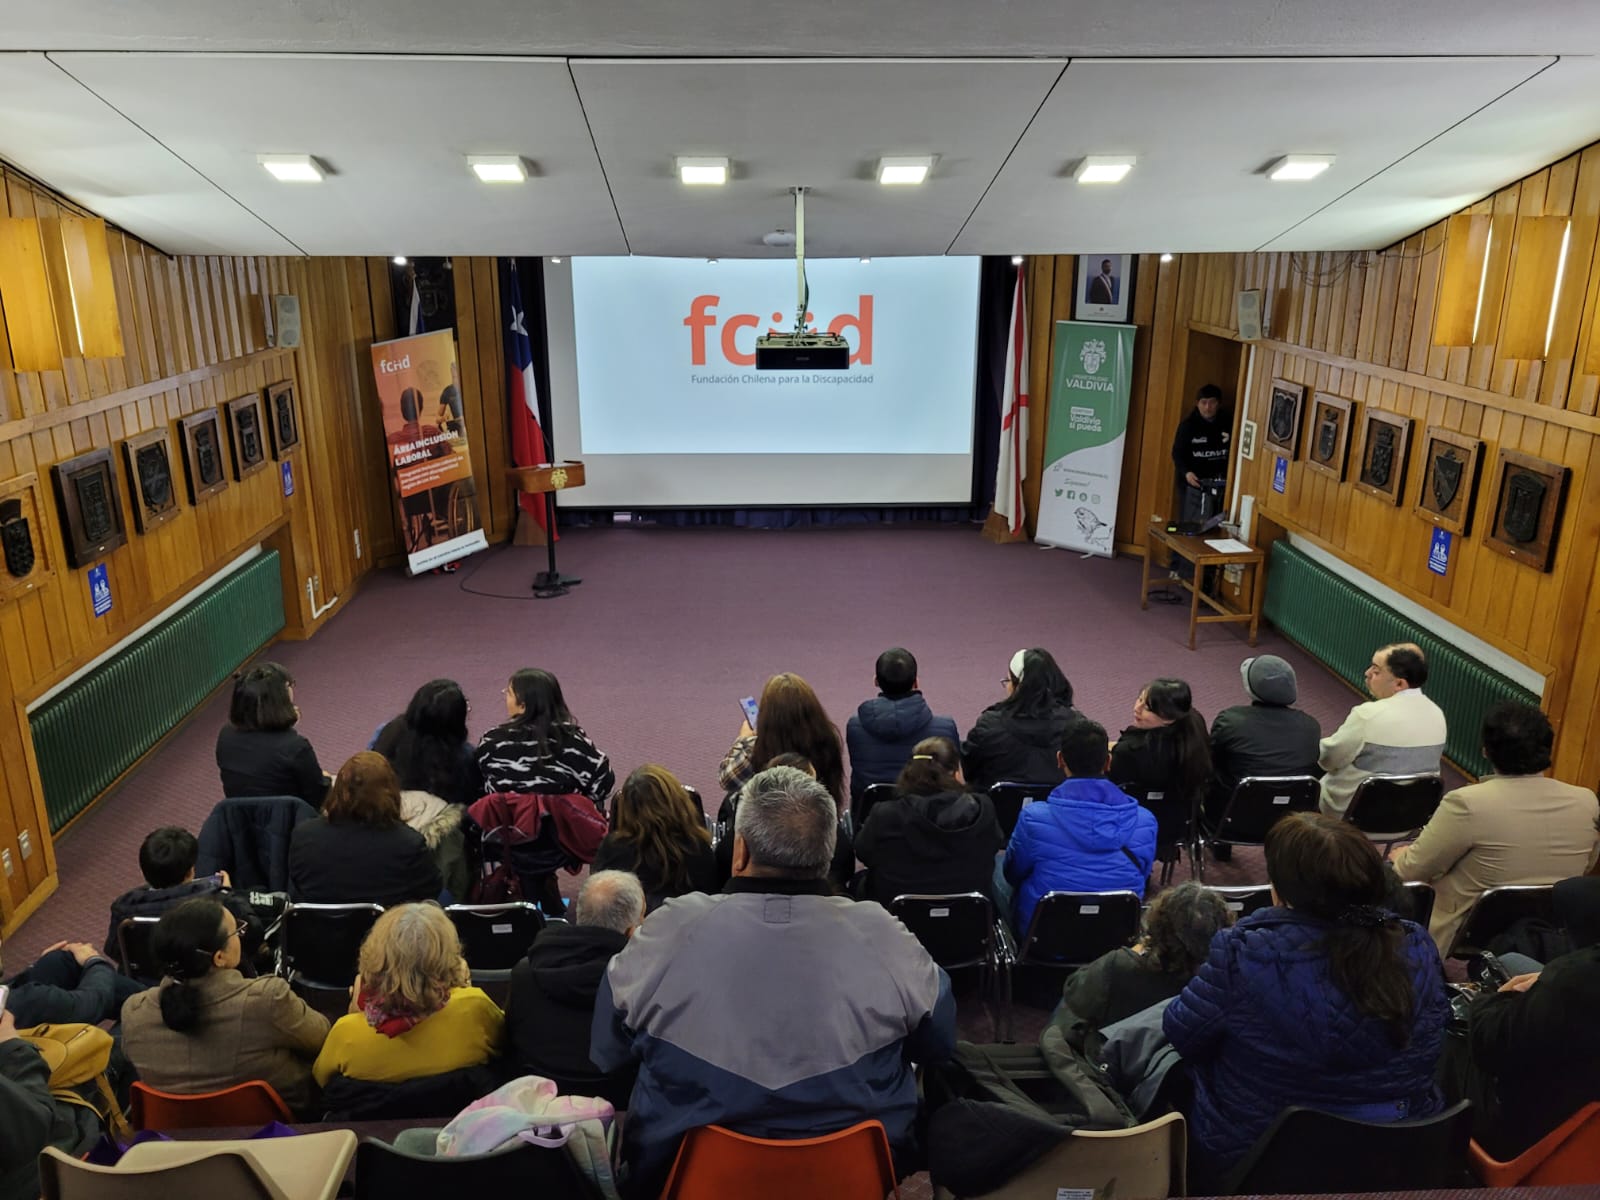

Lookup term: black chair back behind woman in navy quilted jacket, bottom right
[1222,1101,1472,1195]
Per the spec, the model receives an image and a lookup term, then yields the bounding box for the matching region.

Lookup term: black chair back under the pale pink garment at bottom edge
[355,1138,594,1200]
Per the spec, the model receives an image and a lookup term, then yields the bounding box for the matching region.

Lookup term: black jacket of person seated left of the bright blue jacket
[856,792,1005,907]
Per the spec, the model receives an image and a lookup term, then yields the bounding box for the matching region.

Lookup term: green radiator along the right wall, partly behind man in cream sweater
[1264,538,1539,776]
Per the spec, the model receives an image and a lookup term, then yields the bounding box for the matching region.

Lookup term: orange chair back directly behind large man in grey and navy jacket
[661,1122,899,1200]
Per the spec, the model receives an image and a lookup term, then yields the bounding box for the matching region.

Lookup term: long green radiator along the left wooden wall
[29,550,283,832]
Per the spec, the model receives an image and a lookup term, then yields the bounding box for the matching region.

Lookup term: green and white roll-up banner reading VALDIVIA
[1038,322,1134,558]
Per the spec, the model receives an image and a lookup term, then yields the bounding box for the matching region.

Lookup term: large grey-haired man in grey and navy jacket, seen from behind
[589,766,955,1197]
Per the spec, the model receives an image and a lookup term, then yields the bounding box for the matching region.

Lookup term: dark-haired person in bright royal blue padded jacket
[995,717,1155,934]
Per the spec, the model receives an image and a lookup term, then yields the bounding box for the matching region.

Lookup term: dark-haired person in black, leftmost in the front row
[216,662,328,808]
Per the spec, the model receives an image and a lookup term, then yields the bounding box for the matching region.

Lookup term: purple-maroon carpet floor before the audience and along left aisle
[5,526,1376,1036]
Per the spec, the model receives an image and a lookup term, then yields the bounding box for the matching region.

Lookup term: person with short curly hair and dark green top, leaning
[1051,880,1234,1053]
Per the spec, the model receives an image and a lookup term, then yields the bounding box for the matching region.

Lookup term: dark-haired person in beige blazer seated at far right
[1394,701,1600,954]
